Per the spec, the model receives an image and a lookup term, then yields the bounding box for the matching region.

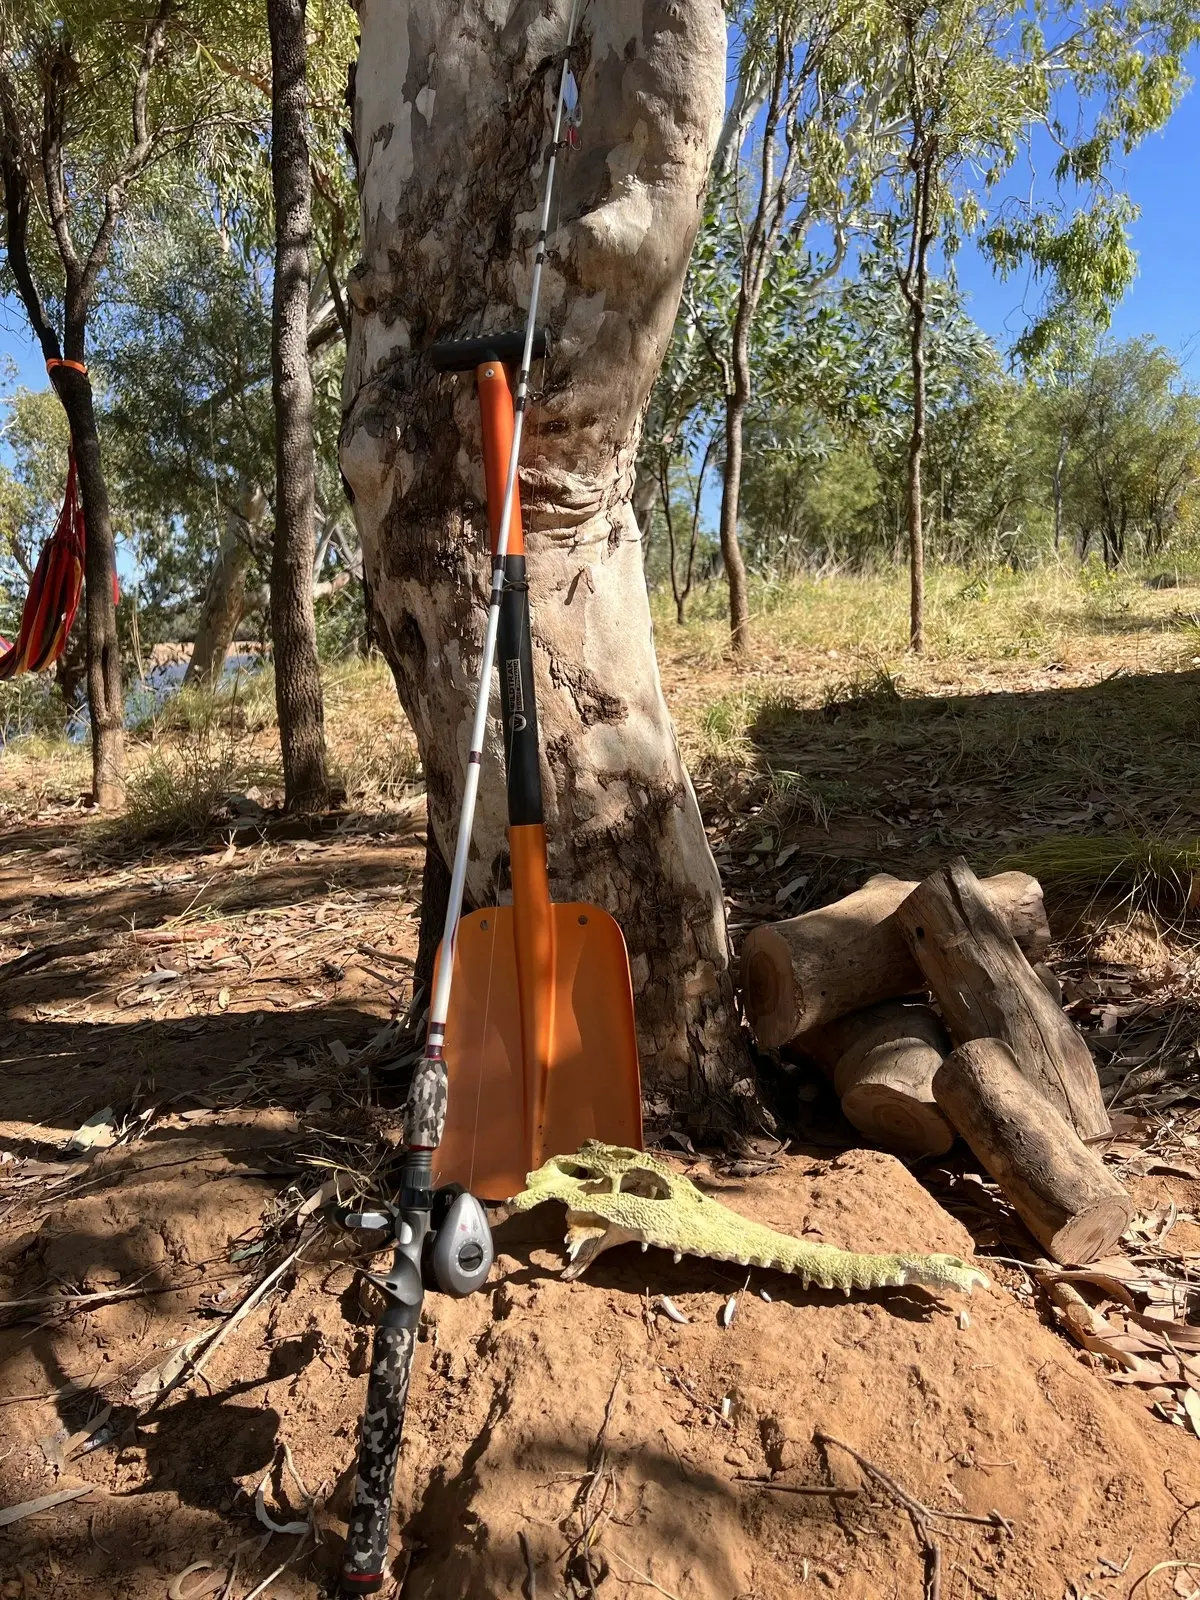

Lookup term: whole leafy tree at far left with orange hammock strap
[0,0,267,806]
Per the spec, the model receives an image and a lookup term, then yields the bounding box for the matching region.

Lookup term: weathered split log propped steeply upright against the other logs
[896,856,1110,1139]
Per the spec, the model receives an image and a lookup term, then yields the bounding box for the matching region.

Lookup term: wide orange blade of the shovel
[434,904,642,1200]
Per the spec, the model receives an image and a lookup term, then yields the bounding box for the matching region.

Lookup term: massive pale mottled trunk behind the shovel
[342,0,749,1102]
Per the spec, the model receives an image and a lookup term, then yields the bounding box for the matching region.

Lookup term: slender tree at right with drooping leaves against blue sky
[880,0,1200,651]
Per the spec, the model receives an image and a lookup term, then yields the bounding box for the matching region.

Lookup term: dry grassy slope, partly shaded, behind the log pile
[656,568,1200,910]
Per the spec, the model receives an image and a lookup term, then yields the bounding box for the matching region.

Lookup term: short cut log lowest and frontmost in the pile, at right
[933,1038,1134,1266]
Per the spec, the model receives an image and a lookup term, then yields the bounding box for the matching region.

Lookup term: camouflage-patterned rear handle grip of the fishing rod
[341,1306,416,1595]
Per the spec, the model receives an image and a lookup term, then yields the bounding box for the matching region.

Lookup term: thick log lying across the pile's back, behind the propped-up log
[741,872,1050,1050]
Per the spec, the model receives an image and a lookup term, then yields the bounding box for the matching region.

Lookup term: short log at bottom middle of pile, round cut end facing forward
[795,1000,954,1160]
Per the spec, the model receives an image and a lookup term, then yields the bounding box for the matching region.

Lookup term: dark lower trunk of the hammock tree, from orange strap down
[53,366,125,811]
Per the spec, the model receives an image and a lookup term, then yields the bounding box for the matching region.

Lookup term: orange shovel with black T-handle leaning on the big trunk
[432,334,642,1200]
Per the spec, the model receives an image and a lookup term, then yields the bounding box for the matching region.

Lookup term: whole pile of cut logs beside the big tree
[742,859,1133,1264]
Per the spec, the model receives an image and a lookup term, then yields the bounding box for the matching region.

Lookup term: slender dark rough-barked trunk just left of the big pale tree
[267,0,330,810]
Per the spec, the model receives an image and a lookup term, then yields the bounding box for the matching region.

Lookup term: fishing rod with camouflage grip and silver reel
[341,9,581,1595]
